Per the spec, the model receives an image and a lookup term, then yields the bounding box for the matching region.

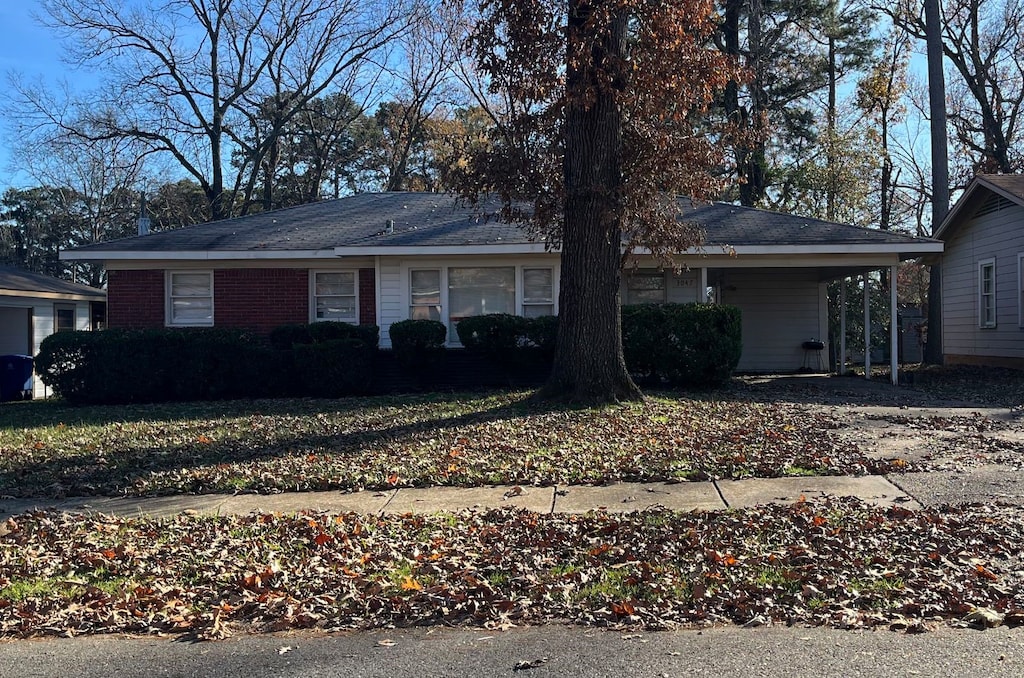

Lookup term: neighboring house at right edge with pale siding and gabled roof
[935,174,1024,369]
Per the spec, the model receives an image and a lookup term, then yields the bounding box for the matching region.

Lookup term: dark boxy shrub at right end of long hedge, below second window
[293,337,377,397]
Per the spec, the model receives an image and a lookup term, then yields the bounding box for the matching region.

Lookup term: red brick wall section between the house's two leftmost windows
[213,268,309,334]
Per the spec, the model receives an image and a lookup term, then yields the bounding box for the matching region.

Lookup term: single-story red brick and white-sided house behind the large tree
[61,193,942,373]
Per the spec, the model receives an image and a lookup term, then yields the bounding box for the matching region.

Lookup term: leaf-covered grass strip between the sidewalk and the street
[0,499,1024,637]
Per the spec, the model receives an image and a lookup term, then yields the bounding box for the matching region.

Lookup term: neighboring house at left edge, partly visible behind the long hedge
[0,266,106,397]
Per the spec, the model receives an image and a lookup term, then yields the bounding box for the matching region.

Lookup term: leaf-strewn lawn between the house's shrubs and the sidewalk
[0,392,905,497]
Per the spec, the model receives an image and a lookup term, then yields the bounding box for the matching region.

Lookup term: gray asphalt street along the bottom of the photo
[0,626,1024,678]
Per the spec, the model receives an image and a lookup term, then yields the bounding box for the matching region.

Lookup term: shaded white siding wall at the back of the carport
[721,269,828,372]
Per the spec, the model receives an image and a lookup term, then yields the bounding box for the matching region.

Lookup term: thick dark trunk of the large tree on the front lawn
[540,0,641,402]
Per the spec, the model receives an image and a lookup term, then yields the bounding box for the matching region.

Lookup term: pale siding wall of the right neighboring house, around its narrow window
[942,205,1024,358]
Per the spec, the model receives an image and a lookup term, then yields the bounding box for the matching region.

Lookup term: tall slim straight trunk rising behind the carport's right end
[925,0,949,365]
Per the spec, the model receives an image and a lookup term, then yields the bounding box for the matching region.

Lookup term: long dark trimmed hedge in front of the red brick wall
[36,323,378,404]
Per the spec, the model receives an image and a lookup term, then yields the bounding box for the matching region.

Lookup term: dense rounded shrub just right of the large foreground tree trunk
[623,304,742,386]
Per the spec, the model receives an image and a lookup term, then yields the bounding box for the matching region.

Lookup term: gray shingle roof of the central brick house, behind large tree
[68,193,937,254]
